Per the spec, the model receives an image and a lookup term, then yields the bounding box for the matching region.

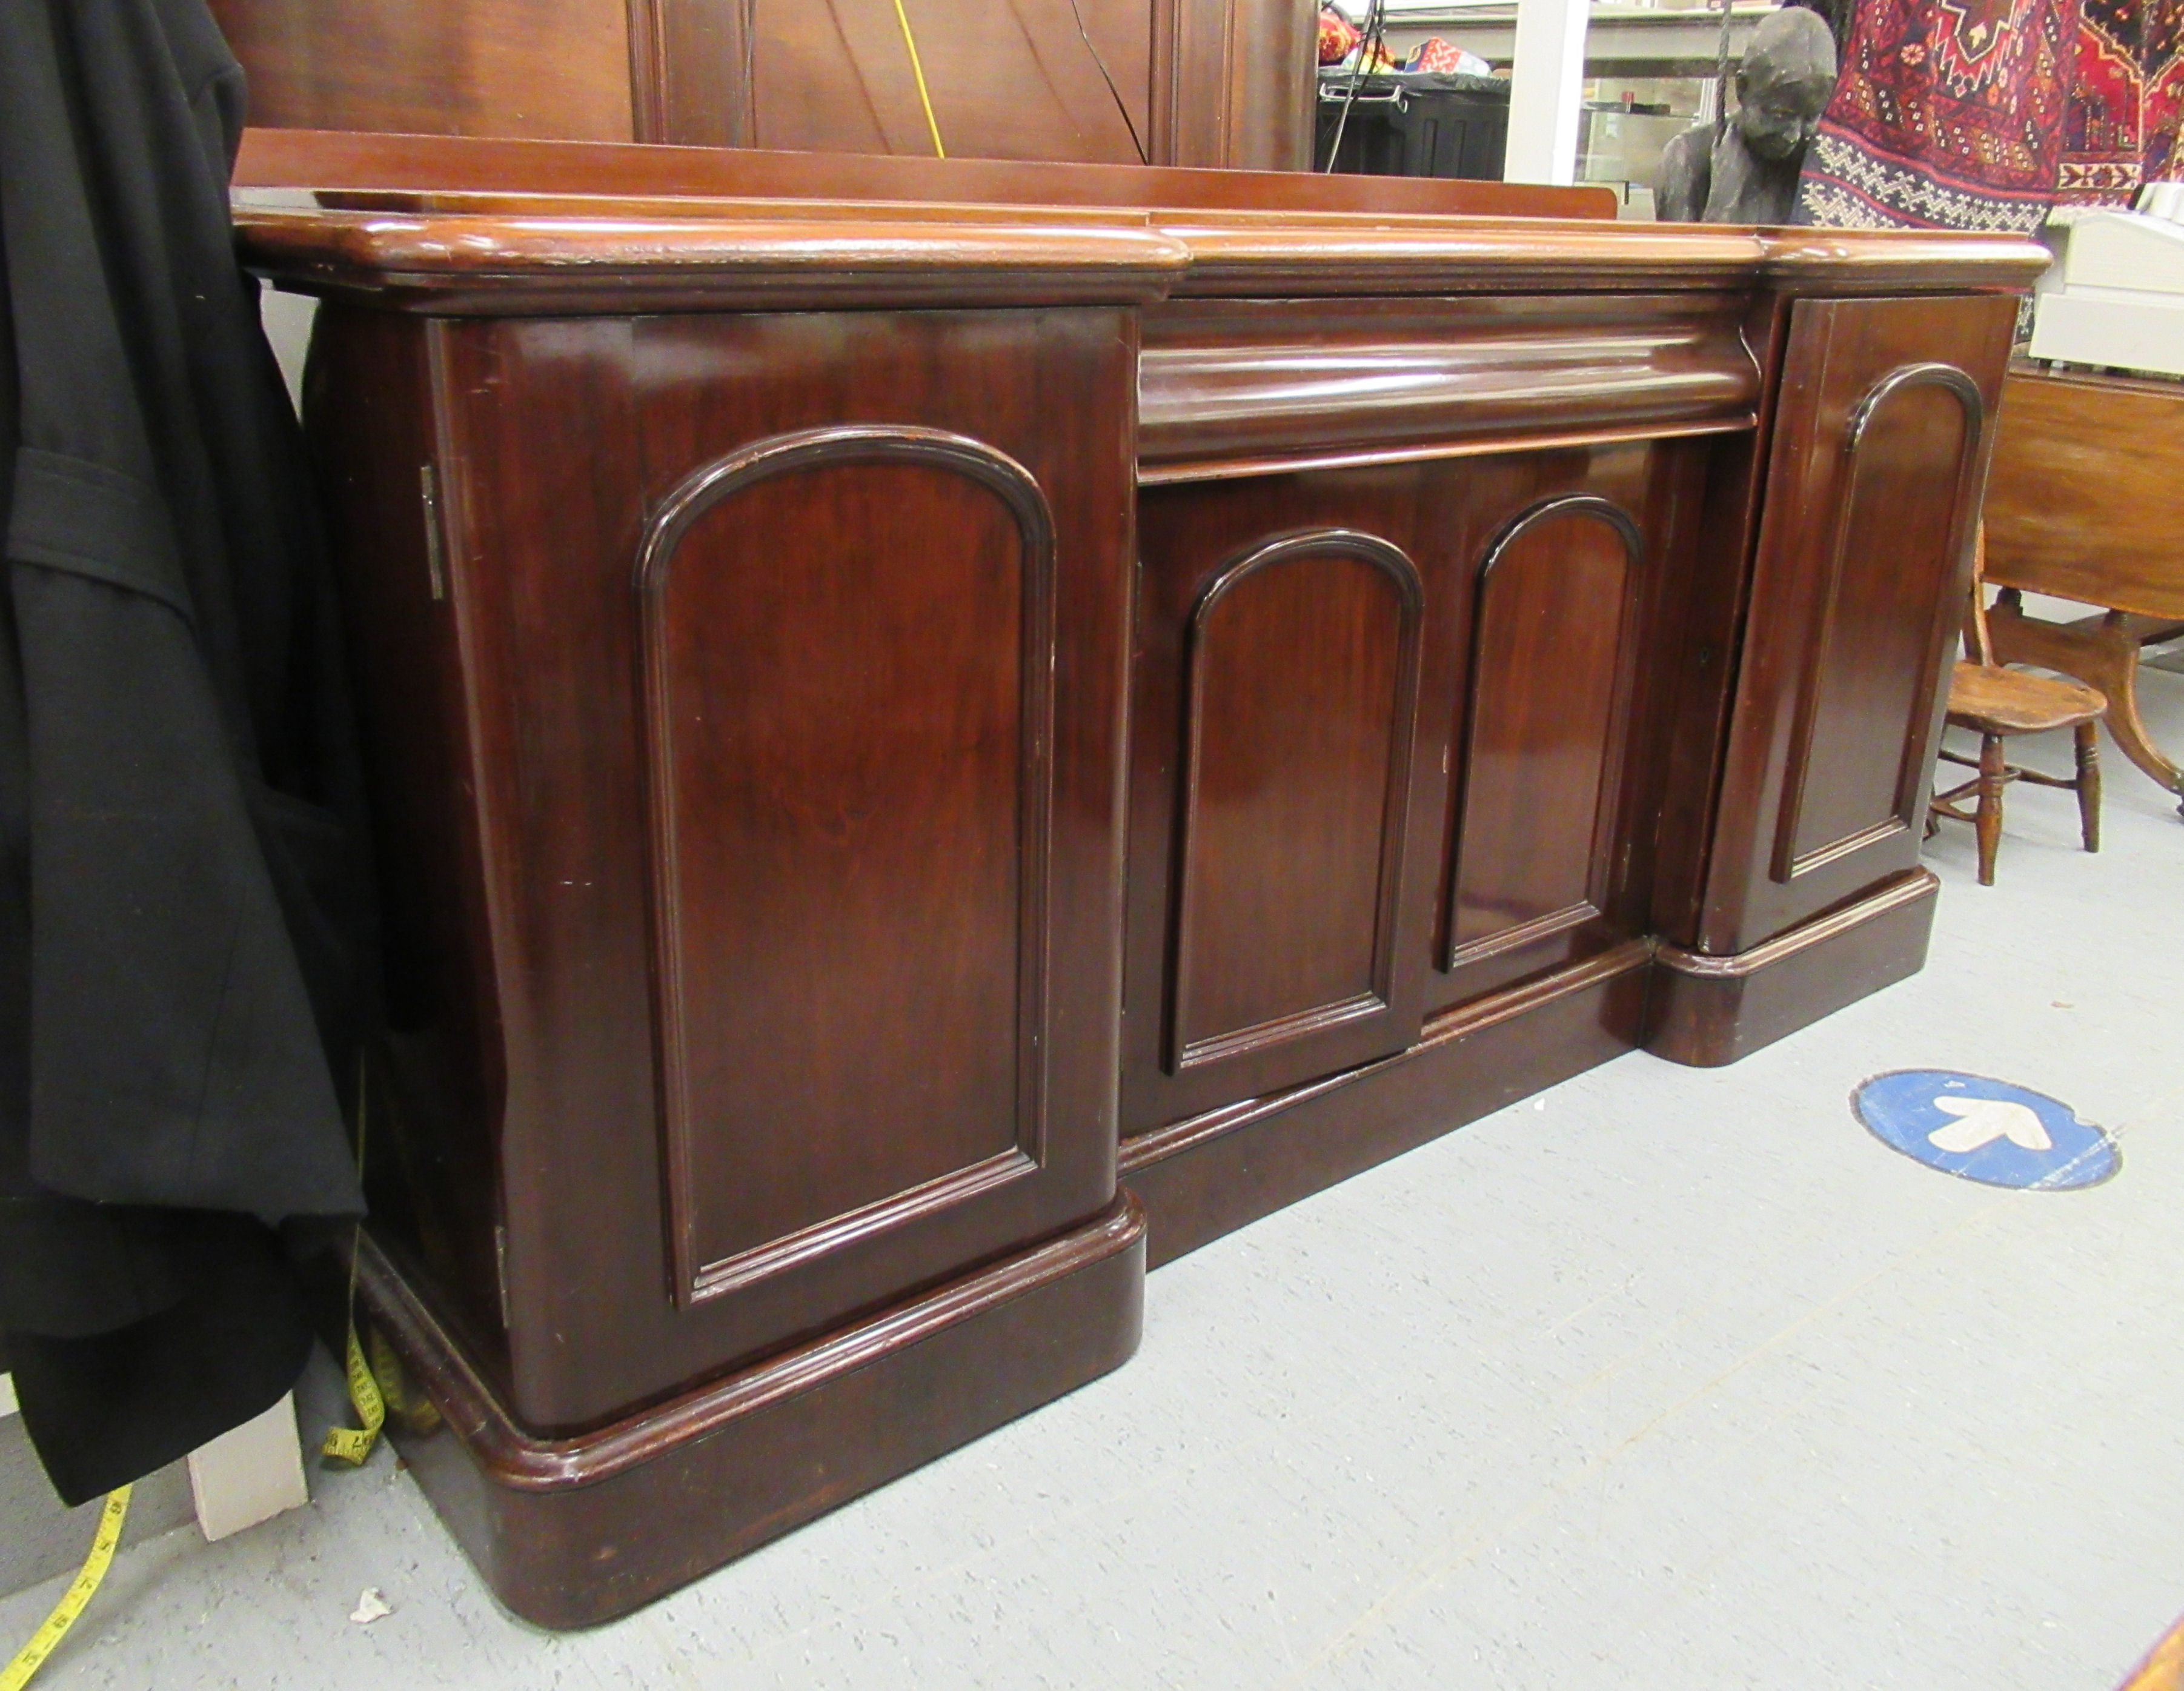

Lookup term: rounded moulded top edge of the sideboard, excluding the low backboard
[236,204,2044,317]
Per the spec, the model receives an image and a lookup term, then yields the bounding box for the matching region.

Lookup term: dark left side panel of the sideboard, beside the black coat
[304,304,505,1361]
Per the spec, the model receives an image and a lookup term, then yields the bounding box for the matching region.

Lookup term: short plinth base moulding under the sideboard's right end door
[1645,869,1942,1068]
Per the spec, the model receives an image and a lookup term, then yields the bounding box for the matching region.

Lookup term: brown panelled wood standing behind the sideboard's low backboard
[212,0,1317,170]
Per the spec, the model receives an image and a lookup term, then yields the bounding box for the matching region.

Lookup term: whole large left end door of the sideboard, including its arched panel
[430,308,1136,1429]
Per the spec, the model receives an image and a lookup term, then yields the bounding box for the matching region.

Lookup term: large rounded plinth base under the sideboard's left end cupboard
[358,1195,1144,1627]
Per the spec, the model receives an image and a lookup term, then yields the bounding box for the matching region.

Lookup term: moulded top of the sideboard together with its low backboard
[221,131,2046,314]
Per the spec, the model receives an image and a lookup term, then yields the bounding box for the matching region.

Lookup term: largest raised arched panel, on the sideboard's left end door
[638,426,1055,1300]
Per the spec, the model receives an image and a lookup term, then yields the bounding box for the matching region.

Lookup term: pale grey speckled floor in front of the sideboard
[13,673,2184,1691]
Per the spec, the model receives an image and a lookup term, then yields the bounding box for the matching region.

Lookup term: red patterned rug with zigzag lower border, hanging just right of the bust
[1797,0,2088,234]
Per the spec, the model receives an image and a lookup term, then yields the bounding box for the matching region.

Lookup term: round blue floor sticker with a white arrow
[1850,1068,2123,1193]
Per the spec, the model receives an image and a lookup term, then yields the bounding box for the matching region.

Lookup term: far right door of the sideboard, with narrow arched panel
[1699,297,2016,955]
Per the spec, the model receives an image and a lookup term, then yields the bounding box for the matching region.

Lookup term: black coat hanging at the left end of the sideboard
[0,0,369,1501]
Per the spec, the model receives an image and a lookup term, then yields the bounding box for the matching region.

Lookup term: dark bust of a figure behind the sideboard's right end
[1653,7,1834,223]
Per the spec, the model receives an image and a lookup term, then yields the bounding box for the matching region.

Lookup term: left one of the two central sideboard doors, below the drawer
[1125,485,1426,1132]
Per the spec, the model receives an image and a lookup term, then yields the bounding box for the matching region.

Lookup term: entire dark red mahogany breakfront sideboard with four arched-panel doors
[238,138,2037,1626]
